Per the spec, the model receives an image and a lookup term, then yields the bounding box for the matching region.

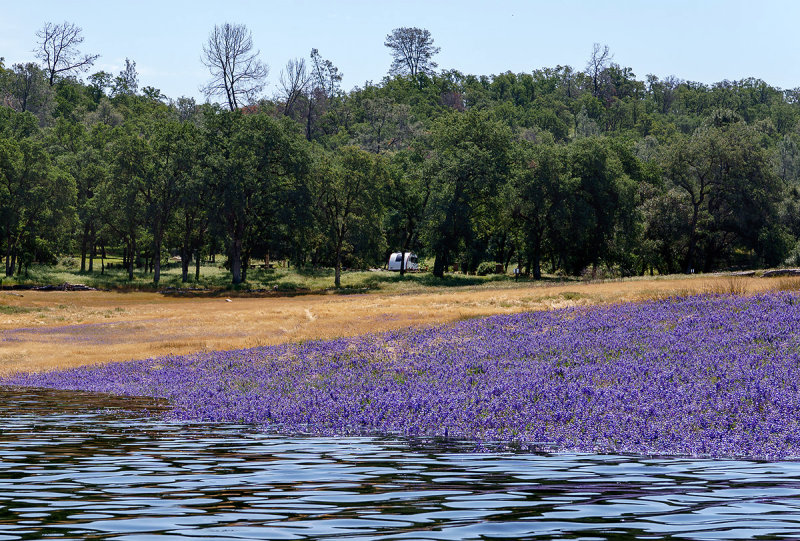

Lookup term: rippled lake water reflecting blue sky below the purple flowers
[0,388,800,541]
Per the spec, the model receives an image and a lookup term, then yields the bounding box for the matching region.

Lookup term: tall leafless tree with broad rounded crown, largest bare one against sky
[202,23,269,111]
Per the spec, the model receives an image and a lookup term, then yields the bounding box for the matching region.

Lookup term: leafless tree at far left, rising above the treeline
[35,21,100,86]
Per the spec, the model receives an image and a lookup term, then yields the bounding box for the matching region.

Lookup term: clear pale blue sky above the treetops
[0,0,800,101]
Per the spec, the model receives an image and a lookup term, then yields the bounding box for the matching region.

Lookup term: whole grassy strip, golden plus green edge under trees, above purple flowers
[0,266,800,373]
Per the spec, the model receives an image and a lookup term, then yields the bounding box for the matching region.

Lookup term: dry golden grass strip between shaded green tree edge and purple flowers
[0,276,800,374]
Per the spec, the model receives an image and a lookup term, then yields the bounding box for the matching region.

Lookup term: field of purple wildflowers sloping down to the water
[0,293,800,459]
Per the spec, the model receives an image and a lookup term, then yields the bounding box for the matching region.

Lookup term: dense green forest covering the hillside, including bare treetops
[0,22,800,286]
